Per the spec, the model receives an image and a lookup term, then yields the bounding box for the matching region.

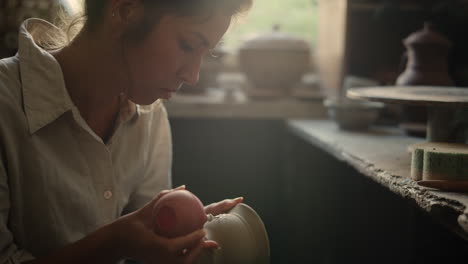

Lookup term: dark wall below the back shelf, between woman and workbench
[170,119,285,263]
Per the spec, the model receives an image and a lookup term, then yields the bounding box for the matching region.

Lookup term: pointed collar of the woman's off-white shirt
[17,18,139,134]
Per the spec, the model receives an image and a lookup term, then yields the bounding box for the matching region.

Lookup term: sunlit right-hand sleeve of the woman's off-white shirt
[124,103,172,213]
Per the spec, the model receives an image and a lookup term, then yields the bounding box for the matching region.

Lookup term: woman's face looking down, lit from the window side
[125,11,231,105]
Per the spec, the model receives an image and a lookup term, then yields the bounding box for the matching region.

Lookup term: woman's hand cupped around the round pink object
[108,186,218,264]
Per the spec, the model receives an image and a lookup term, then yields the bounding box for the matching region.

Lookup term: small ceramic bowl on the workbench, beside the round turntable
[324,99,384,130]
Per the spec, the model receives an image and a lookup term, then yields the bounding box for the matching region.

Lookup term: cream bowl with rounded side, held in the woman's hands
[197,204,270,264]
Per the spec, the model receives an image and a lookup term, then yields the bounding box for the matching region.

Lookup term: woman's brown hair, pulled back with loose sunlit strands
[37,0,253,50]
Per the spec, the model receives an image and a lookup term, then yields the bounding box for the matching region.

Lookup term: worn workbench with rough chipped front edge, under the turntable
[287,120,468,240]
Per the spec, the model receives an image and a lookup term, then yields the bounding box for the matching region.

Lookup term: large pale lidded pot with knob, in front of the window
[239,25,311,97]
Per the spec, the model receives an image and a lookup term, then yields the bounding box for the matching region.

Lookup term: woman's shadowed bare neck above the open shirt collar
[53,30,126,141]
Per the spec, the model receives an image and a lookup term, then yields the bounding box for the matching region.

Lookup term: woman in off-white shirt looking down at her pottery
[0,0,251,264]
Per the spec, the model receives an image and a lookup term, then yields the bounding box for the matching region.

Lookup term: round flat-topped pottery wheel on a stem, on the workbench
[346,86,468,142]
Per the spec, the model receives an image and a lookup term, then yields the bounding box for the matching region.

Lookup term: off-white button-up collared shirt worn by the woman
[0,19,172,264]
